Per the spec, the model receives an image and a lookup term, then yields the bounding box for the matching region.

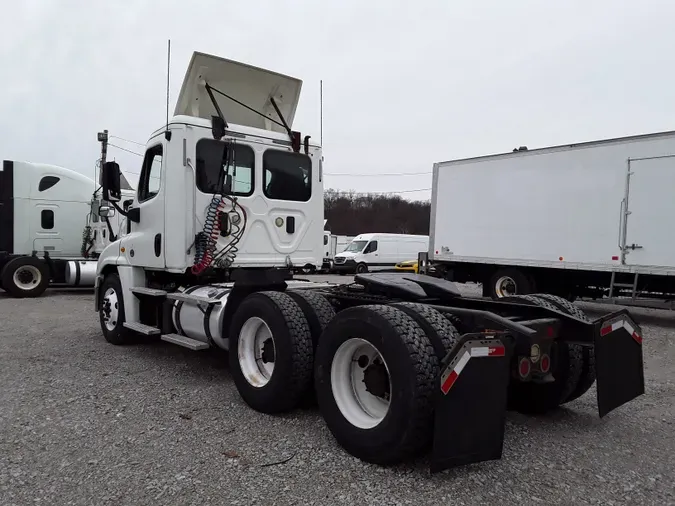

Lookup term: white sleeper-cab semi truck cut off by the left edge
[0,160,129,297]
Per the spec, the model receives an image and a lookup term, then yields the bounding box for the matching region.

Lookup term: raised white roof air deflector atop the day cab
[174,52,302,133]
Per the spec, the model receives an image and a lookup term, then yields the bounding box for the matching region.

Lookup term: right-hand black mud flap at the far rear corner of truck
[593,309,645,417]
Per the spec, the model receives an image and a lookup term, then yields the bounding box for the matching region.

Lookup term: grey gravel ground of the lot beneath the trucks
[0,278,675,506]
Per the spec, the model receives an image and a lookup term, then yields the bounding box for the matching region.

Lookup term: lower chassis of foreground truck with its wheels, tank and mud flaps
[96,267,644,472]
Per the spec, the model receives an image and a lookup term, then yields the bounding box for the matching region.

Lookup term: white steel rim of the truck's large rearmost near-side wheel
[330,338,391,429]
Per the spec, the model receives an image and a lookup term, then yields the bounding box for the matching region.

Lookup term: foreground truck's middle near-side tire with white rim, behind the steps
[229,292,313,414]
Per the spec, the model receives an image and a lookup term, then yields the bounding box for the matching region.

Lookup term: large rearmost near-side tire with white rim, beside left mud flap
[314,305,439,465]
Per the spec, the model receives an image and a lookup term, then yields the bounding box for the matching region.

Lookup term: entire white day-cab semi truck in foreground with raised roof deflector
[94,53,644,471]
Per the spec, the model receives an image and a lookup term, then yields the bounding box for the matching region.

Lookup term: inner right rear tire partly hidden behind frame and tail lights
[502,295,583,414]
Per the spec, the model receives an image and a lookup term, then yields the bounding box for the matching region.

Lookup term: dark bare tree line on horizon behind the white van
[323,189,431,235]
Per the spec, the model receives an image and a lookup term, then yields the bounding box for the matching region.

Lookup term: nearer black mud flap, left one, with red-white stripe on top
[430,334,512,473]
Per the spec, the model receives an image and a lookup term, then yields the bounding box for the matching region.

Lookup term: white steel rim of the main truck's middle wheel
[237,316,277,388]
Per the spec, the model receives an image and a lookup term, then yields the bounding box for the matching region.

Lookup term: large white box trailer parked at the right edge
[429,128,675,305]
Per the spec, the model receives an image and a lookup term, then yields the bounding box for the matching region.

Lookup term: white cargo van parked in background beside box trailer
[333,234,429,273]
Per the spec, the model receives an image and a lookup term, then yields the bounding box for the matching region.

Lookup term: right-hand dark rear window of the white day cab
[263,149,312,202]
